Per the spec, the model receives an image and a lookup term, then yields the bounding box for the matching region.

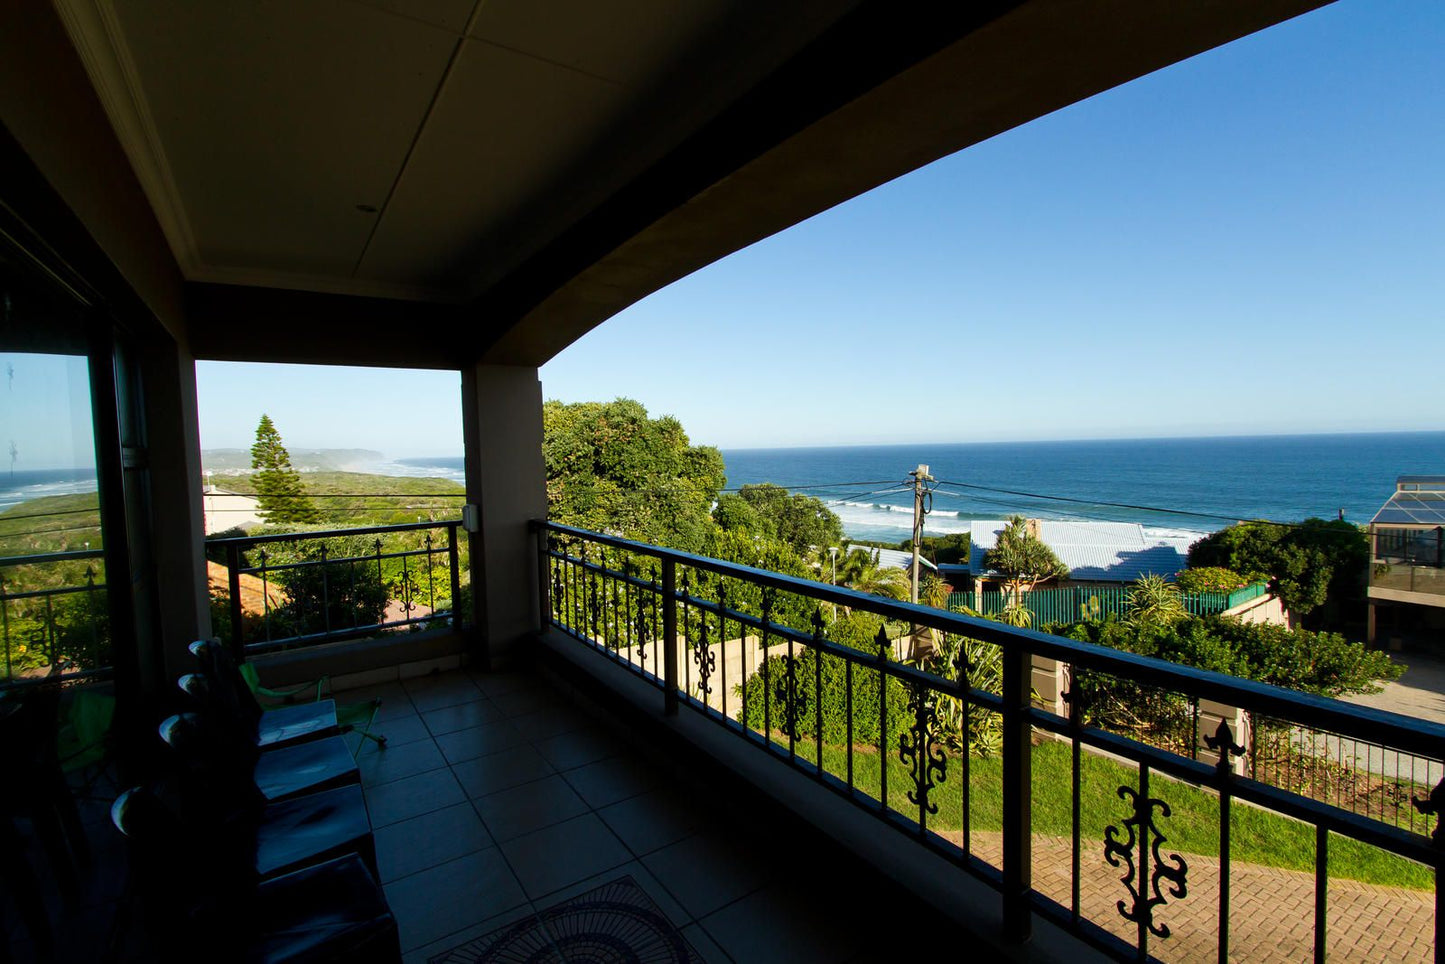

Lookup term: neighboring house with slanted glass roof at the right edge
[1367,475,1445,642]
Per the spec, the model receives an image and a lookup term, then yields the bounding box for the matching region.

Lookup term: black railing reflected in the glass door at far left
[0,549,111,685]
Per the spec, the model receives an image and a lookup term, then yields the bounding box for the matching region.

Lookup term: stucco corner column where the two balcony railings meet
[461,364,546,669]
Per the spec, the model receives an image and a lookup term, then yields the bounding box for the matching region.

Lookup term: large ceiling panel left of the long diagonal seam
[116,0,455,274]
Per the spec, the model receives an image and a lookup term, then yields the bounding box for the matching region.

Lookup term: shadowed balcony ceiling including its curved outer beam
[42,0,1319,364]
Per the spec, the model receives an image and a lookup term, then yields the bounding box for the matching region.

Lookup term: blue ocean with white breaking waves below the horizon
[401,432,1445,541]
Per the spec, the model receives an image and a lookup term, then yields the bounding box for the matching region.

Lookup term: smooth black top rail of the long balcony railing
[533,520,1445,760]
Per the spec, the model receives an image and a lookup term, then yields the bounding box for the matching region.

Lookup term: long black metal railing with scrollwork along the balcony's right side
[538,523,1445,961]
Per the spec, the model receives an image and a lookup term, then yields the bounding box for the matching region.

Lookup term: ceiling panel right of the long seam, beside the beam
[360,40,630,286]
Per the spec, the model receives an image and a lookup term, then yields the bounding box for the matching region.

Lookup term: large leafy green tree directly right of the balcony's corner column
[542,399,725,552]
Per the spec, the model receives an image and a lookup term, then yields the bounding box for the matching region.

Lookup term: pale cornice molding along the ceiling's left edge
[55,0,201,277]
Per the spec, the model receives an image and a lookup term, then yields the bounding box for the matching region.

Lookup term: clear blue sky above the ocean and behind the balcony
[186,0,1445,455]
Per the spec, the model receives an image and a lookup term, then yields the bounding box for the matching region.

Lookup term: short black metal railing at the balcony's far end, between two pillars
[207,519,464,653]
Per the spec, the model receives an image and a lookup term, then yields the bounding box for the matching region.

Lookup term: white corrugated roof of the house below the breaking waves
[939,519,1205,590]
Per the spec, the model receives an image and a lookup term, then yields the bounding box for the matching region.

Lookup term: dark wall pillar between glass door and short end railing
[140,344,211,679]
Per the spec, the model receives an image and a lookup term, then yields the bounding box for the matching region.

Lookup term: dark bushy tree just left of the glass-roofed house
[1189,519,1370,624]
